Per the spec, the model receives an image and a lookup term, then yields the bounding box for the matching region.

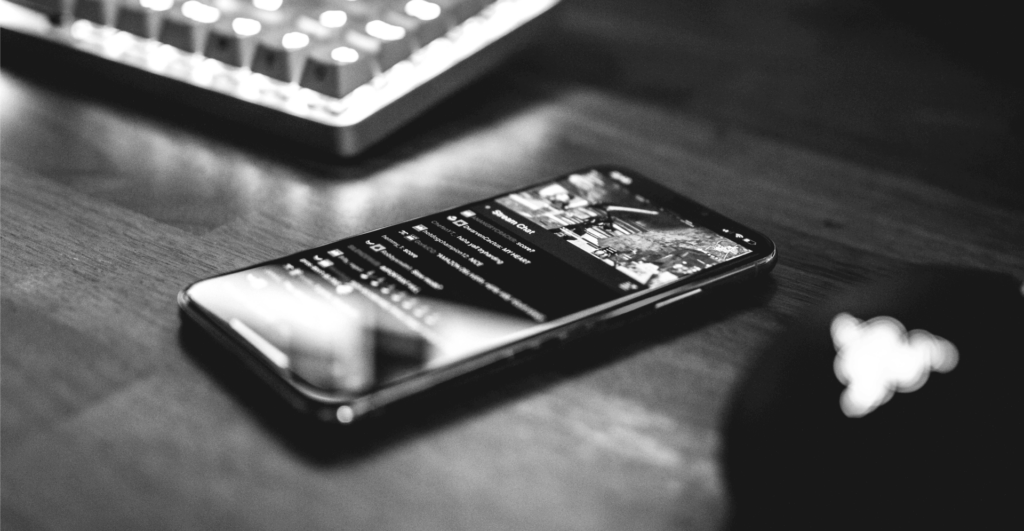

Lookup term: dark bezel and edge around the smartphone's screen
[178,165,776,424]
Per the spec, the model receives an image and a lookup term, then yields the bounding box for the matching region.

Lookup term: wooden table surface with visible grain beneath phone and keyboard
[0,0,1024,530]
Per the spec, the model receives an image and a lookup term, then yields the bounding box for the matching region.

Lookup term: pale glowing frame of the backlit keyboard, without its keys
[0,0,561,157]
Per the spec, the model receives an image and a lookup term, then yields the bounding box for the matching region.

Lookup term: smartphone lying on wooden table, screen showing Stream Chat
[178,166,775,425]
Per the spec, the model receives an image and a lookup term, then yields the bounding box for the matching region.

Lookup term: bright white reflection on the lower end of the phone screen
[189,264,535,395]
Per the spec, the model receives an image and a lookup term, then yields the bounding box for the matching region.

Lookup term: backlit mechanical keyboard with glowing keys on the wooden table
[0,0,560,156]
